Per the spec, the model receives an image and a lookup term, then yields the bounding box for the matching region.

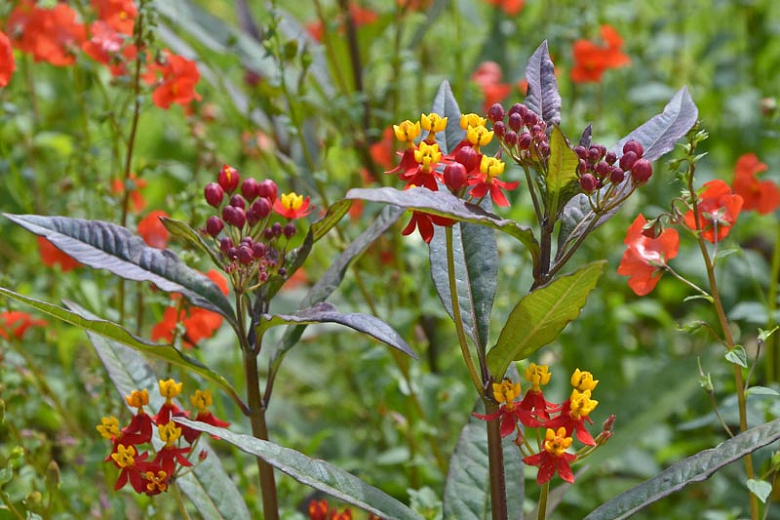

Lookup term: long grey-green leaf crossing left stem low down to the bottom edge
[177,419,421,520]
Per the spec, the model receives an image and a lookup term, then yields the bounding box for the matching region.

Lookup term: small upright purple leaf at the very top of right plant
[525,40,561,127]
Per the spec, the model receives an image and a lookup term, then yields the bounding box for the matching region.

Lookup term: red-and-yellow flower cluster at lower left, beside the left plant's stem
[97,379,230,495]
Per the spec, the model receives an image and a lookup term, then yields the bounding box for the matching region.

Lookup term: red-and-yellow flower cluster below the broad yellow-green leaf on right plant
[474,363,614,484]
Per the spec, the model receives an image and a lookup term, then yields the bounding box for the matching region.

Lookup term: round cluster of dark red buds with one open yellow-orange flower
[203,165,312,290]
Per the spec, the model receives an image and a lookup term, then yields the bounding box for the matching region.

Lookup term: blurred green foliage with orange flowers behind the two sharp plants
[0,0,780,519]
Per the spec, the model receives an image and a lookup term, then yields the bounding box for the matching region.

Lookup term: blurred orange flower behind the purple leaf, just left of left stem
[152,269,229,348]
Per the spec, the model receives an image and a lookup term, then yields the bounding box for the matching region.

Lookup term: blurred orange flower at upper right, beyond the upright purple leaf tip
[571,25,631,83]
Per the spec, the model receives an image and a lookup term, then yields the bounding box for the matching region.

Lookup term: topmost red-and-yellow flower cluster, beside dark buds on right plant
[385,113,518,242]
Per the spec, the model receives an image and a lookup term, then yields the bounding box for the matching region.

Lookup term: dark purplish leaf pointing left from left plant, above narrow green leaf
[4,213,236,327]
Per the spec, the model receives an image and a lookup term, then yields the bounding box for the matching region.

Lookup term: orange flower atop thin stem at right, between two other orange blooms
[685,179,744,243]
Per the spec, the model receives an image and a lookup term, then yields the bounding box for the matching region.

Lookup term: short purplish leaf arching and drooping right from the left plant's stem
[257,302,417,359]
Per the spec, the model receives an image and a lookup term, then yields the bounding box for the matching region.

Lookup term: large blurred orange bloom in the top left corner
[6,0,86,67]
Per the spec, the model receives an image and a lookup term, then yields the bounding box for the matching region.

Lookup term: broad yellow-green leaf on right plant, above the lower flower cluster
[487,260,606,380]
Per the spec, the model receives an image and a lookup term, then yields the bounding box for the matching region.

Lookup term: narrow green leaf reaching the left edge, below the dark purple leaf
[0,287,241,412]
